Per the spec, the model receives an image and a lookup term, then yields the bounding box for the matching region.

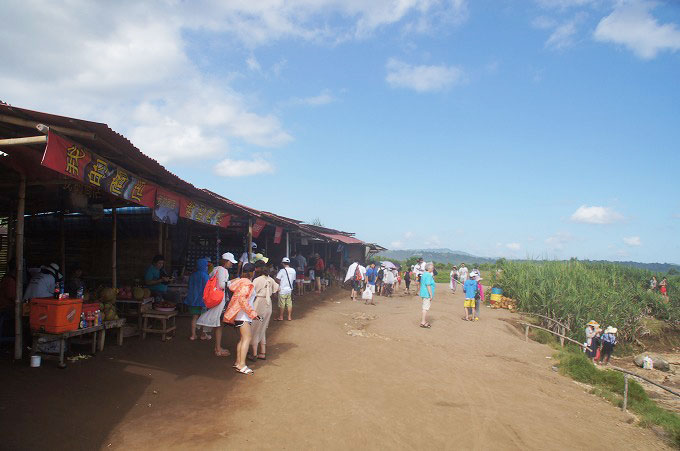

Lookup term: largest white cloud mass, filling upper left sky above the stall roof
[0,0,466,169]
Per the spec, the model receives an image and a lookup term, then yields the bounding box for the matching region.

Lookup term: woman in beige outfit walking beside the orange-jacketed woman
[248,260,279,360]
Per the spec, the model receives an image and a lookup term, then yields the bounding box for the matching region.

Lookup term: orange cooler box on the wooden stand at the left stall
[31,298,83,334]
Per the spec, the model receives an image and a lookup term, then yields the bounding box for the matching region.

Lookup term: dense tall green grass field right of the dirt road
[494,260,680,341]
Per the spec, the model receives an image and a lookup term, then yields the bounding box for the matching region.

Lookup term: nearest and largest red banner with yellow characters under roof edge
[41,131,157,208]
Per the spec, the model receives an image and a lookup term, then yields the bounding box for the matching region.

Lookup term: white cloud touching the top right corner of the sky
[594,0,680,59]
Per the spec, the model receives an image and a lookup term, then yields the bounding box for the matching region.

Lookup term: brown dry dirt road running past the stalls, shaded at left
[0,284,666,450]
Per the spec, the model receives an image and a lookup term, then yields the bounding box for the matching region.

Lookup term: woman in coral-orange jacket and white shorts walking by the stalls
[224,263,262,374]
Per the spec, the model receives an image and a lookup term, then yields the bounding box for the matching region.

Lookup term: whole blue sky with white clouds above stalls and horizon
[0,0,680,263]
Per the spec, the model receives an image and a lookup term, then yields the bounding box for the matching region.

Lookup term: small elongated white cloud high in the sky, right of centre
[385,58,463,92]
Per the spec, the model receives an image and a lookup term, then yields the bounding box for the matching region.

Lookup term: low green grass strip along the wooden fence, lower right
[556,349,680,448]
